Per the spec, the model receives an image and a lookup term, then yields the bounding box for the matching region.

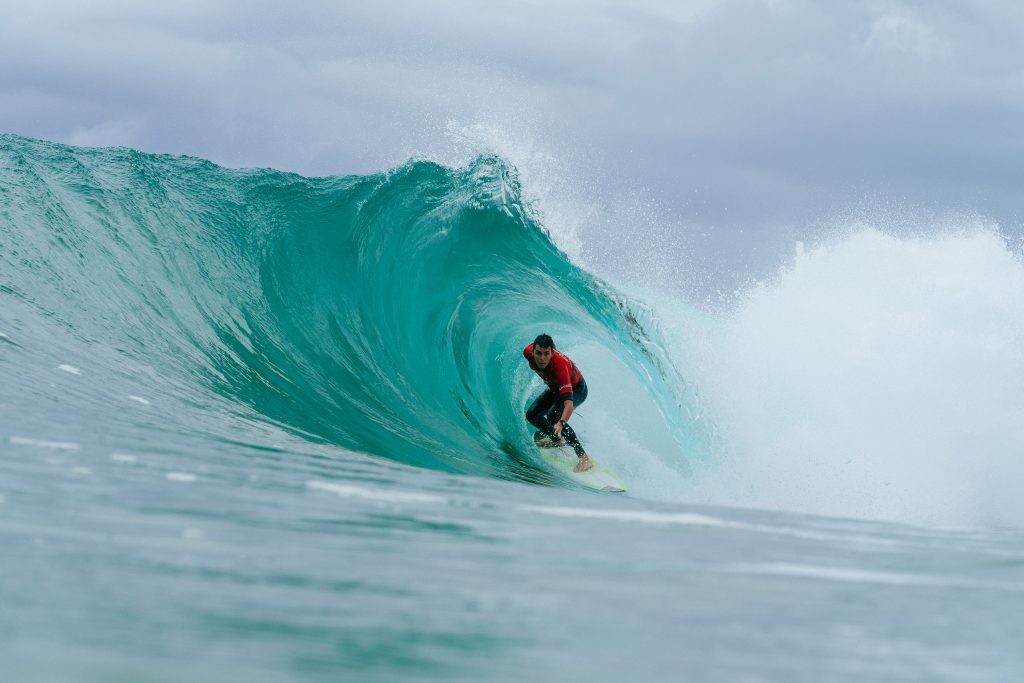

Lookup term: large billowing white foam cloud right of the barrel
[662,226,1024,527]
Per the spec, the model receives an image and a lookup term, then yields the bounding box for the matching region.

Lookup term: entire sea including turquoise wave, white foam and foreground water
[0,135,1024,683]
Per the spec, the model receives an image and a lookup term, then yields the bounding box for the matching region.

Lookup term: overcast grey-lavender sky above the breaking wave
[0,0,1024,290]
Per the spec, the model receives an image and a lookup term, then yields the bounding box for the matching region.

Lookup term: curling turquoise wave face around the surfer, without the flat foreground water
[0,135,707,478]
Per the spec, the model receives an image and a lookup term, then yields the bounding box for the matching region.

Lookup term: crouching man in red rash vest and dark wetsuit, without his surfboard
[522,335,593,472]
